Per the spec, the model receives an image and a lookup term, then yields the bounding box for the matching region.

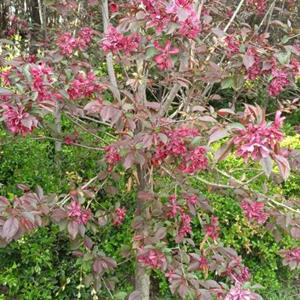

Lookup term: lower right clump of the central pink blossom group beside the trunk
[179,146,208,174]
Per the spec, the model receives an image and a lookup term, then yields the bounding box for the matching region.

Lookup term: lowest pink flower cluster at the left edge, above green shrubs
[2,105,38,136]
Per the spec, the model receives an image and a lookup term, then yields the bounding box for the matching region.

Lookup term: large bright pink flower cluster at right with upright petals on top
[233,112,284,160]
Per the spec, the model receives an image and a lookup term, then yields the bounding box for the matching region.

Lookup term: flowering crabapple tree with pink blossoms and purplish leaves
[0,0,300,300]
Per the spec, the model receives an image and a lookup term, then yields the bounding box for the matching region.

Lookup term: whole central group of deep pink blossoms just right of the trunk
[152,128,208,174]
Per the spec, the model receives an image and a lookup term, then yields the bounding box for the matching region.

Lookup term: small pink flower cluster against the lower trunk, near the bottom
[137,249,167,269]
